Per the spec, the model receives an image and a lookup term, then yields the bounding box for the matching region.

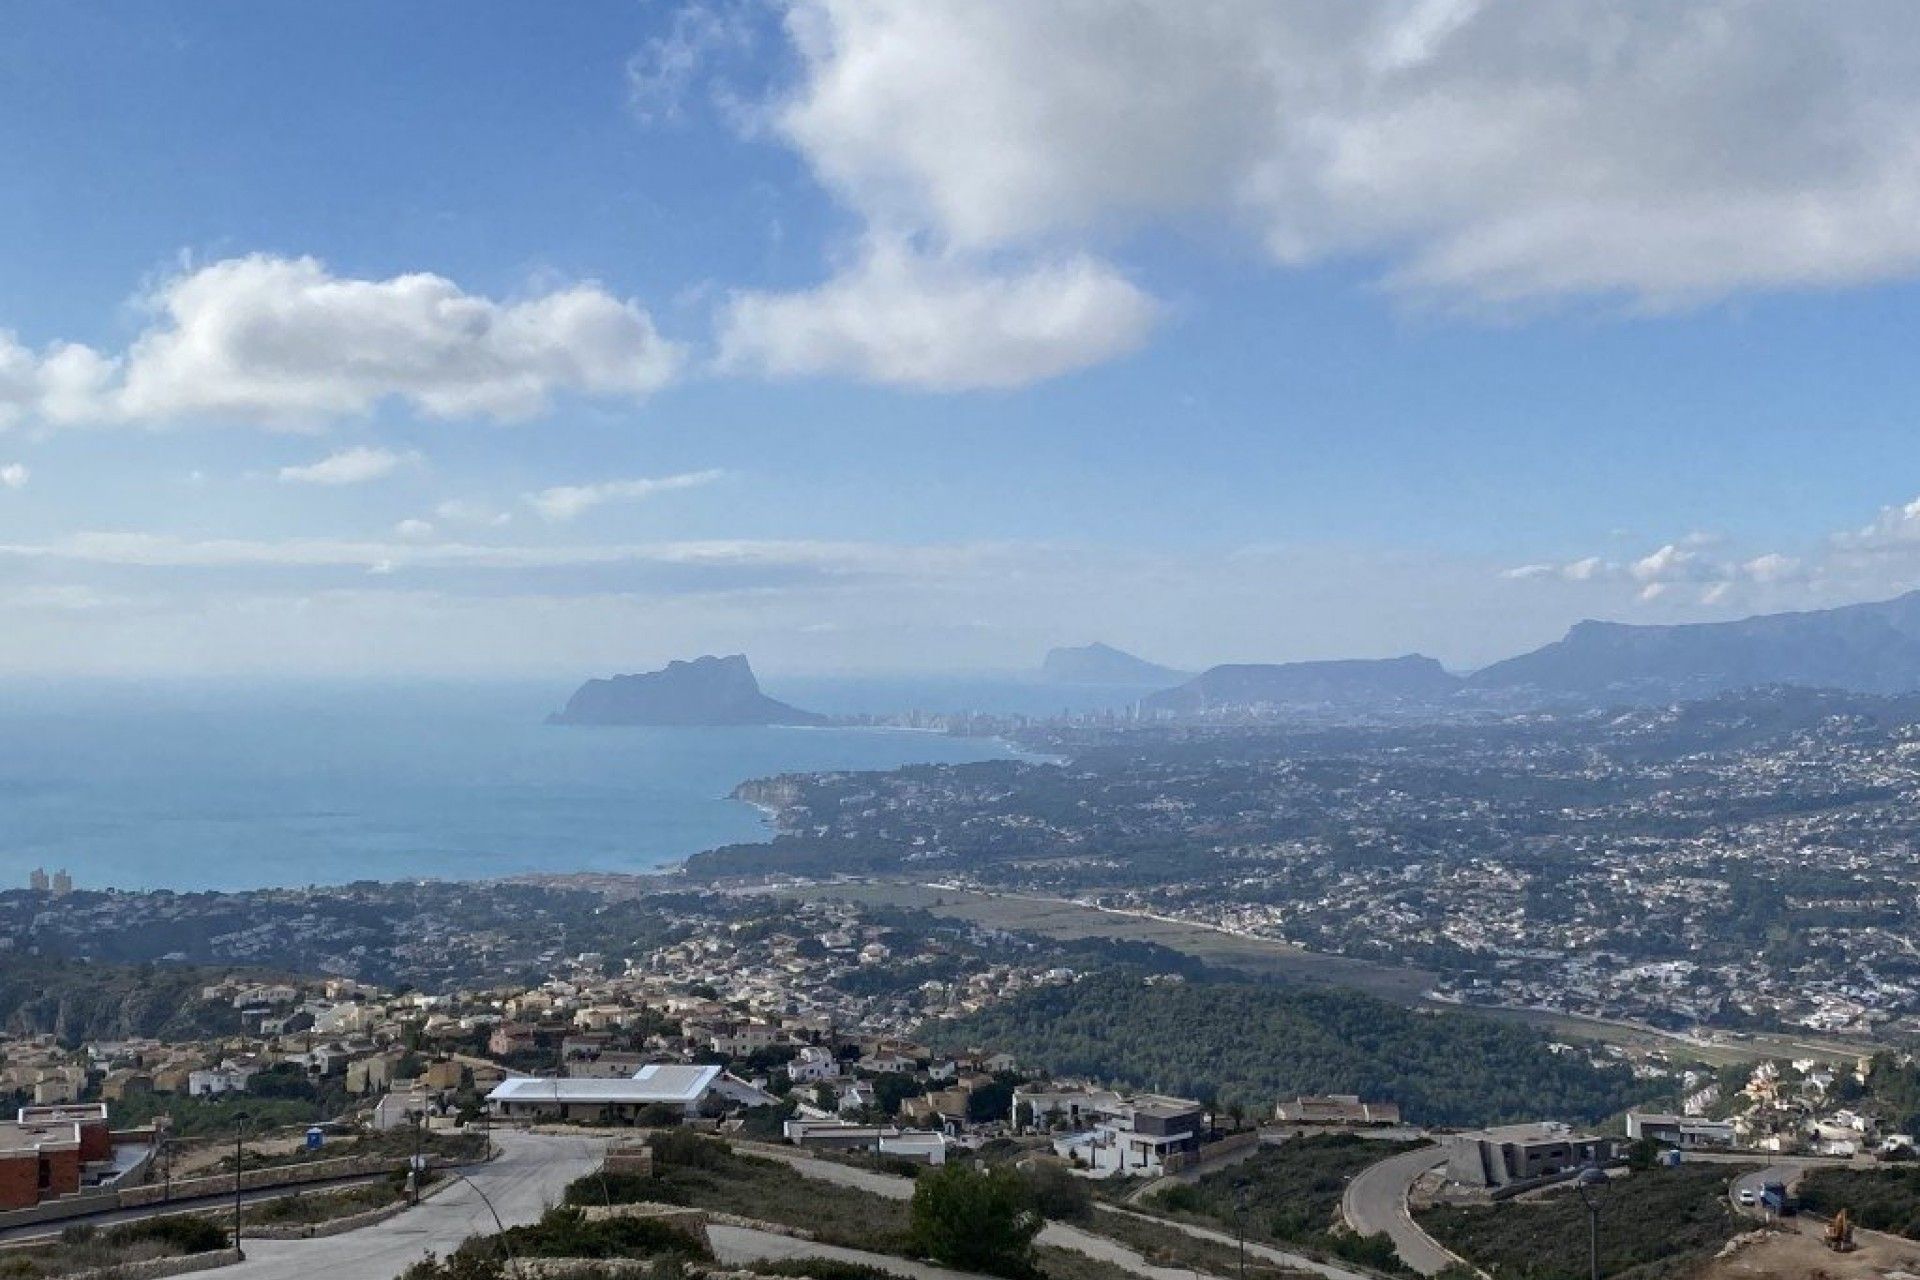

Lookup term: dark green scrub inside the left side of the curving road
[1148,1134,1415,1267]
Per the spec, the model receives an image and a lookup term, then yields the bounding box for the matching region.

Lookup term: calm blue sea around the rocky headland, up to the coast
[0,677,1139,890]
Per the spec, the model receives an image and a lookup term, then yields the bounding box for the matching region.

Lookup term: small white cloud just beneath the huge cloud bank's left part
[720,244,1156,391]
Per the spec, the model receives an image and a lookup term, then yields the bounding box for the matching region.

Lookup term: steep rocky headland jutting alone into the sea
[547,654,828,727]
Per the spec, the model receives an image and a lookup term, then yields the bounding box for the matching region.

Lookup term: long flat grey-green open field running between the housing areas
[781,881,1434,1004]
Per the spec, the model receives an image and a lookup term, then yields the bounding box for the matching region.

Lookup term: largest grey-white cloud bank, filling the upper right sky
[774,0,1920,305]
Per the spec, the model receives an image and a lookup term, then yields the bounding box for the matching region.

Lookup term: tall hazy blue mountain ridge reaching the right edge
[1467,591,1920,700]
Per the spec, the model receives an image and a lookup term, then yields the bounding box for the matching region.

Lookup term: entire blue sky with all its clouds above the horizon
[0,0,1920,676]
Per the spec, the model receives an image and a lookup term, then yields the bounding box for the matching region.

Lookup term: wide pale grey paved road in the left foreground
[219,1130,605,1280]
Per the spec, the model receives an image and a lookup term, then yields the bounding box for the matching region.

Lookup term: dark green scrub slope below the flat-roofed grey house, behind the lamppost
[1419,1165,1753,1280]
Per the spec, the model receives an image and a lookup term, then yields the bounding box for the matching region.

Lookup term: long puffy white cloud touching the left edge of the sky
[0,253,682,428]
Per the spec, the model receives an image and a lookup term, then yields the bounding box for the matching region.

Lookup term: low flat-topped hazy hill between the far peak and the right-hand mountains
[1142,654,1461,716]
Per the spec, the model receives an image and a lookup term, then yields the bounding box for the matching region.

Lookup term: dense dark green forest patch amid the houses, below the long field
[922,973,1647,1125]
